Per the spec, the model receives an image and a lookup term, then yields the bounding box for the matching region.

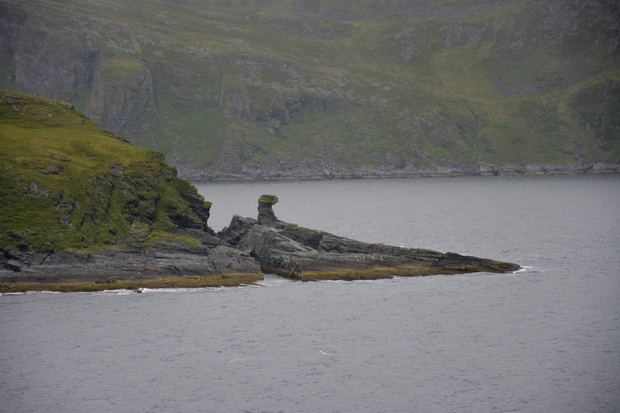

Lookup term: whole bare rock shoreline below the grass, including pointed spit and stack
[0,195,520,293]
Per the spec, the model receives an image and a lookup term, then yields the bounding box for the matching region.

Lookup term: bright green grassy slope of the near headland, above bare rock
[0,91,210,253]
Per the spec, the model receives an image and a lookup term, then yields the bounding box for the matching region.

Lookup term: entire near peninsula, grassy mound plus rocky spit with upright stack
[0,92,519,293]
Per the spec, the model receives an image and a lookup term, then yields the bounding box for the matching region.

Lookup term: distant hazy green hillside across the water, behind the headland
[0,0,620,177]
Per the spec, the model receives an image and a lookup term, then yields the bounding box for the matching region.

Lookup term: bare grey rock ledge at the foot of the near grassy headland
[0,230,262,283]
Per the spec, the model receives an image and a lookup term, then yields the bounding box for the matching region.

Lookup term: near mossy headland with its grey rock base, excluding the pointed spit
[0,91,262,292]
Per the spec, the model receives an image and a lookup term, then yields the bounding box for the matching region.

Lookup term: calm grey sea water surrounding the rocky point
[0,175,620,413]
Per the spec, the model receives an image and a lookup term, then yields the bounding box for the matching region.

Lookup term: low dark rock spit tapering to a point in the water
[219,197,519,281]
